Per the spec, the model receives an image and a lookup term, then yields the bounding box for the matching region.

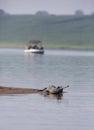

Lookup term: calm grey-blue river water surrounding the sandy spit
[0,49,94,130]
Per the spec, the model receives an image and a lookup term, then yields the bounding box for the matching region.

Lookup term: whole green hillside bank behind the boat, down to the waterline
[0,15,94,50]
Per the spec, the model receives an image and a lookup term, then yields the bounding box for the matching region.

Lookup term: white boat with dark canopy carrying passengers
[24,40,44,54]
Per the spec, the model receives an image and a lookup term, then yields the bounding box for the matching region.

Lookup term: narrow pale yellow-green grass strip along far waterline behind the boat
[0,42,94,50]
